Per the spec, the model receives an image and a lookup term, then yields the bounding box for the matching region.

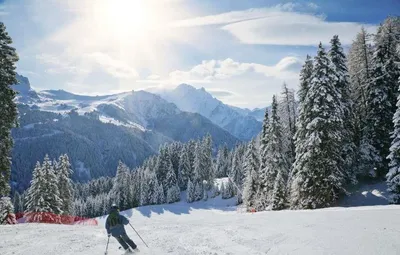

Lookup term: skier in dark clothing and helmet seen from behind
[106,204,139,253]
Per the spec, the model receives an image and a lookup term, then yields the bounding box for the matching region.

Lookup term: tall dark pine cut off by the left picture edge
[0,22,18,197]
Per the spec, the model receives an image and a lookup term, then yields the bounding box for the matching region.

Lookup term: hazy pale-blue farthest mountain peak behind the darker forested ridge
[159,84,262,140]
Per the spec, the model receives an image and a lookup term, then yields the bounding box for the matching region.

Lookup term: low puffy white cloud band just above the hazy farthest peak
[169,57,302,82]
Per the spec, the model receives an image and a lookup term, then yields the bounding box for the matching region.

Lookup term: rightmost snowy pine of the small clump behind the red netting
[56,154,74,215]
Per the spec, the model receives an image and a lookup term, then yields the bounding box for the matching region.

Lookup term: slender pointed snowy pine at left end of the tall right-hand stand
[257,95,290,210]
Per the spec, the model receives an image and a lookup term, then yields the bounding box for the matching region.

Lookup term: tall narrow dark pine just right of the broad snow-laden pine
[328,35,357,184]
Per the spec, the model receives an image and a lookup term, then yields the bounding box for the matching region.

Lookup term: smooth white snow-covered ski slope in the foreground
[0,202,400,255]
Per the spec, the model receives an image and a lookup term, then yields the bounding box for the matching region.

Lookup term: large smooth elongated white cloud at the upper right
[172,3,376,46]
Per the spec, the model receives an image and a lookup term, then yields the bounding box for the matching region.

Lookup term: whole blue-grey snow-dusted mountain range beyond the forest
[11,75,262,190]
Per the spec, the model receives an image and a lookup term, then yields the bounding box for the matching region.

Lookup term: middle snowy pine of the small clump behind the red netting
[42,154,62,215]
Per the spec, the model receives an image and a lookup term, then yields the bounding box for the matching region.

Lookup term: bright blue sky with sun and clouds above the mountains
[0,0,400,109]
